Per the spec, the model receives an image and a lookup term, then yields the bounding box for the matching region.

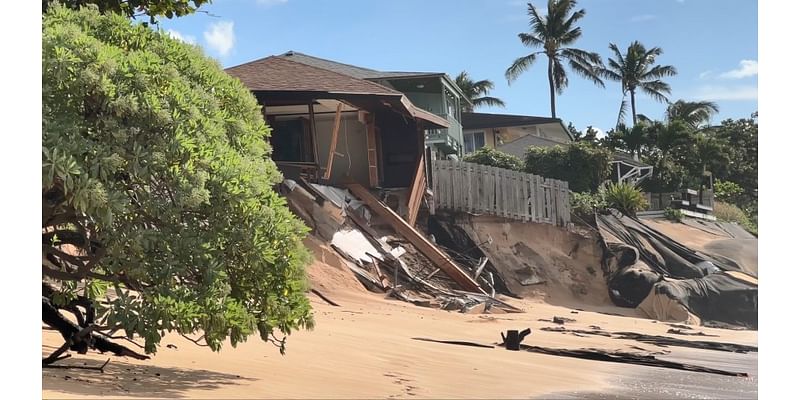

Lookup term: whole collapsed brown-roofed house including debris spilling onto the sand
[227,56,518,312]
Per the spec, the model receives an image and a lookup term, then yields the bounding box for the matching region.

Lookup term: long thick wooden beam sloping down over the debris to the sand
[345,182,486,294]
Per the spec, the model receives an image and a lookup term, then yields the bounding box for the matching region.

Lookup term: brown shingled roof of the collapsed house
[225,56,403,96]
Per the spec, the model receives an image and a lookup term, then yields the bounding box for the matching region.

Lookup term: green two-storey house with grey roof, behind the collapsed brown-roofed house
[277,51,472,158]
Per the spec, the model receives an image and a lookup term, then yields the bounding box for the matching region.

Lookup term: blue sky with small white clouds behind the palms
[161,0,758,130]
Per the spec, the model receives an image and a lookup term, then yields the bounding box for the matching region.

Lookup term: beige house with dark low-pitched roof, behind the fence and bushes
[462,112,574,158]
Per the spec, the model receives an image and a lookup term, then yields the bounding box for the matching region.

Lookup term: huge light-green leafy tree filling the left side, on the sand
[42,5,313,361]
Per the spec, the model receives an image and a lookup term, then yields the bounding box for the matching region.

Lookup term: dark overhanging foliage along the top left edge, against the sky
[42,0,211,22]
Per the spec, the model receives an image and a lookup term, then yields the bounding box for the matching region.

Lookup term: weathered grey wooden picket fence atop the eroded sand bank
[431,160,570,226]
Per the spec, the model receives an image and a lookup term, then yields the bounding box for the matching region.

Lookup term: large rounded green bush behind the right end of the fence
[525,142,612,193]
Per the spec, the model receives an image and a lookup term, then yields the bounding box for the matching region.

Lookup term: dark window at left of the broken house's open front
[269,118,314,162]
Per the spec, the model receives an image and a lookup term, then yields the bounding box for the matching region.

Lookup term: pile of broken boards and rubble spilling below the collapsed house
[281,179,522,313]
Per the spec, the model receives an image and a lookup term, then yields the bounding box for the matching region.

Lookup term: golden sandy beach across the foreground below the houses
[42,276,757,398]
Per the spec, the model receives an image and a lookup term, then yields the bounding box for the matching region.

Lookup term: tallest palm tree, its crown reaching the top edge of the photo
[506,0,605,118]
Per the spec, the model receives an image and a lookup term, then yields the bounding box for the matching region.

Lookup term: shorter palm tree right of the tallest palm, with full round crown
[599,41,677,124]
